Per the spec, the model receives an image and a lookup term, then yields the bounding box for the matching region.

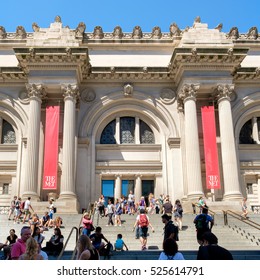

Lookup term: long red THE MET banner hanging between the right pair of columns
[201,106,220,189]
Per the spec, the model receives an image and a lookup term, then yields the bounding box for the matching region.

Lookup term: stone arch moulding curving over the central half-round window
[79,92,179,143]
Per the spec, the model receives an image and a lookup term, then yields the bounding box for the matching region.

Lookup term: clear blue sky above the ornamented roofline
[0,0,260,33]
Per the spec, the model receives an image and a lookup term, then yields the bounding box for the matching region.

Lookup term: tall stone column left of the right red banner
[179,84,203,199]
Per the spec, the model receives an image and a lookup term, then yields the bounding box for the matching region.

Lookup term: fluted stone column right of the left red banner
[59,84,79,199]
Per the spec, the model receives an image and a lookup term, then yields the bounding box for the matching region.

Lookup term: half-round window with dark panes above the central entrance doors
[100,117,155,144]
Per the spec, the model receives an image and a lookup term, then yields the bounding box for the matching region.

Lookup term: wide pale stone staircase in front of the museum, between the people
[0,211,260,260]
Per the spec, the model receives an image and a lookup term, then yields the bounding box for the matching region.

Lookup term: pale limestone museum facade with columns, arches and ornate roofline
[0,16,260,213]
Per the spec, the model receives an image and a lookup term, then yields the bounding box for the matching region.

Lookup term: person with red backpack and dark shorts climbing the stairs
[133,209,154,250]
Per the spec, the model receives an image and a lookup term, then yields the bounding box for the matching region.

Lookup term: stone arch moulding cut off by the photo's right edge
[233,92,260,141]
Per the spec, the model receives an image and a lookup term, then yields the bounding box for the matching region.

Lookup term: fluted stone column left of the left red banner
[22,84,45,200]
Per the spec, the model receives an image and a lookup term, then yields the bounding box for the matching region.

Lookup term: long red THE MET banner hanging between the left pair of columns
[42,106,60,190]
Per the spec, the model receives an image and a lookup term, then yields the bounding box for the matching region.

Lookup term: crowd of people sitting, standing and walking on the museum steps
[0,191,248,260]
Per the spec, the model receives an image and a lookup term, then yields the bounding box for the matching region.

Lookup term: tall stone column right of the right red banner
[216,85,242,200]
